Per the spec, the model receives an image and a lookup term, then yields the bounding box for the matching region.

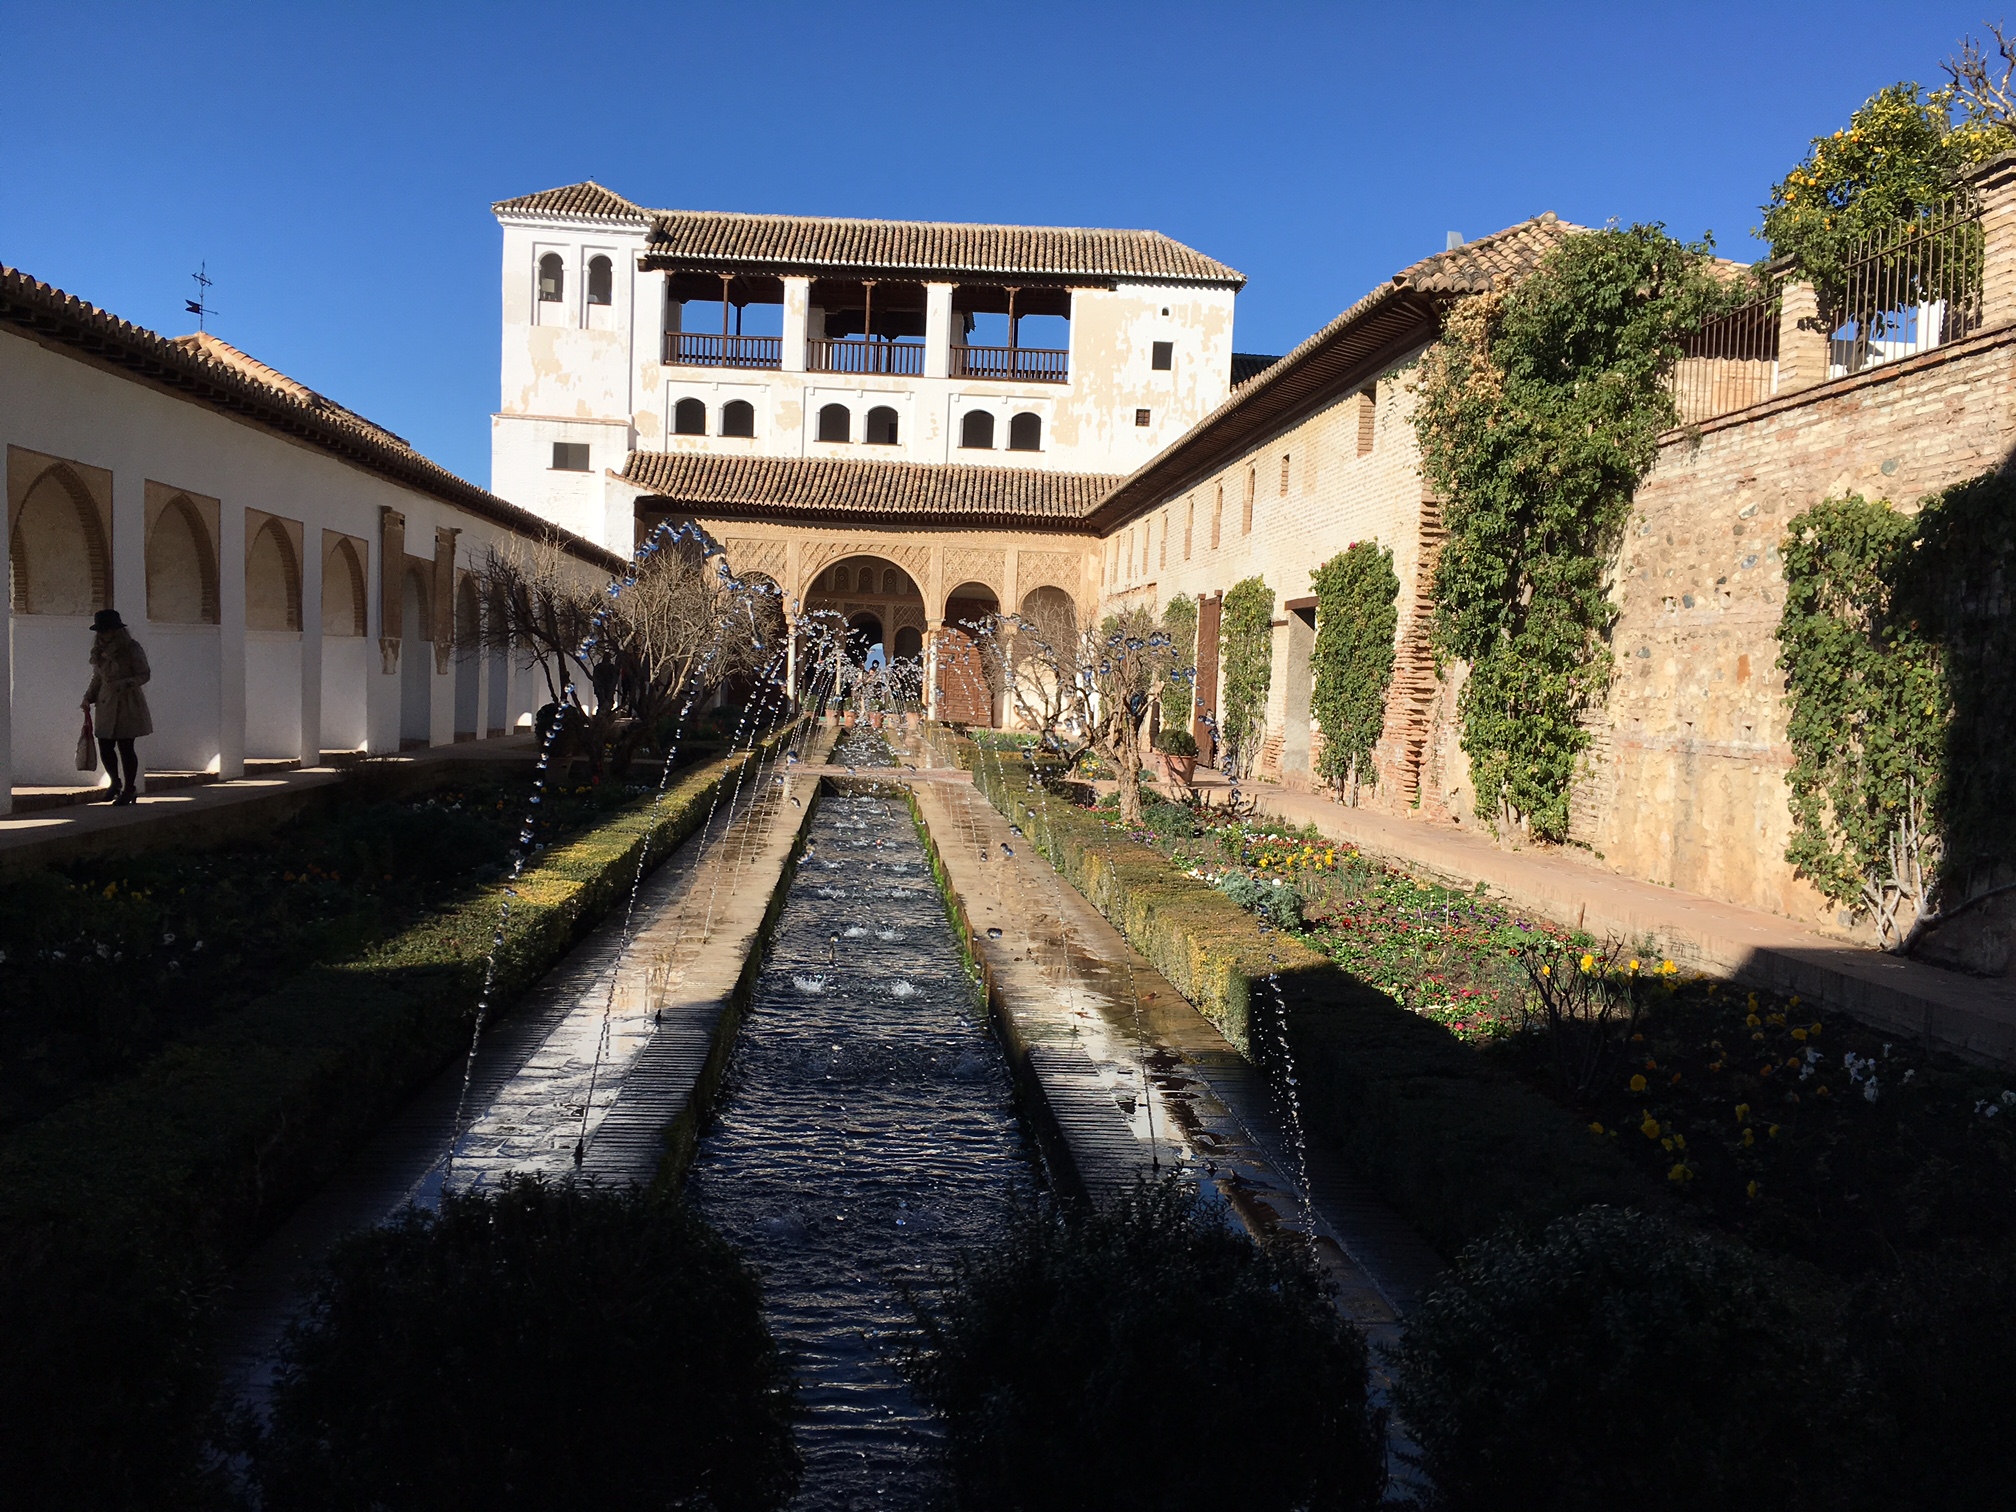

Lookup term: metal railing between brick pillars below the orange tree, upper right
[1820,194,1982,377]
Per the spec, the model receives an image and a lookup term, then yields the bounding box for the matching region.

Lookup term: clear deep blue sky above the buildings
[0,0,1982,482]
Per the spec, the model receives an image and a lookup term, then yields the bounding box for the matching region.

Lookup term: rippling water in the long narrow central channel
[687,758,1036,1512]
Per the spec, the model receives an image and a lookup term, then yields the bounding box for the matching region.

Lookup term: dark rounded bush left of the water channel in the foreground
[252,1177,800,1512]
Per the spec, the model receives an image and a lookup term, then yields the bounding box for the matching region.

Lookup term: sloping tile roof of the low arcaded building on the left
[0,266,623,573]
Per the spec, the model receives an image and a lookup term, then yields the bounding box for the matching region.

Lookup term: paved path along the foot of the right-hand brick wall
[1200,774,2016,1064]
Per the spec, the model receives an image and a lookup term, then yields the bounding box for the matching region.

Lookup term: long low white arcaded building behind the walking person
[0,268,623,806]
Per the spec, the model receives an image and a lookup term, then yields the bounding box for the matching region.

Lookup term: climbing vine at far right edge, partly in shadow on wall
[1778,474,2016,950]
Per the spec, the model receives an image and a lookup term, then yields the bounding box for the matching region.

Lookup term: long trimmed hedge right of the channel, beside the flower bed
[939,736,1665,1254]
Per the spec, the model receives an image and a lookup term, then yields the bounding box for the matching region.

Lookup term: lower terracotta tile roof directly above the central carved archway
[623,452,1117,532]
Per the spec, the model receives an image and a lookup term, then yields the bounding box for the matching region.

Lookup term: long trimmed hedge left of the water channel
[0,733,786,1506]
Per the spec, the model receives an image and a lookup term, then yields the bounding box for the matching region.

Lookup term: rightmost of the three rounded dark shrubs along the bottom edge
[1395,1208,1847,1512]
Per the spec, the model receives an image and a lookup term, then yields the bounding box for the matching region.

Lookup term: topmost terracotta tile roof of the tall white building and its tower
[492,181,1246,288]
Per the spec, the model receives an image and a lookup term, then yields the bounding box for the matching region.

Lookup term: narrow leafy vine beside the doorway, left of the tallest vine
[1308,540,1399,798]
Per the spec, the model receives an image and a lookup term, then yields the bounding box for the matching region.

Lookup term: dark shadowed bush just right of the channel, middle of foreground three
[911,1181,1385,1512]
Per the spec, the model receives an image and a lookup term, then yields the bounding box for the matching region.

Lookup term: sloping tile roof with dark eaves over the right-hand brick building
[1089,210,1585,532]
